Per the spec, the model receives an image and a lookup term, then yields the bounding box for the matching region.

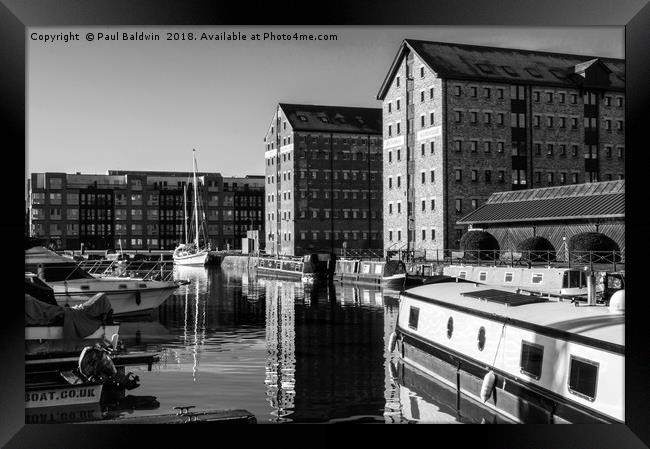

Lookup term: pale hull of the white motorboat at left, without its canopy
[50,278,178,316]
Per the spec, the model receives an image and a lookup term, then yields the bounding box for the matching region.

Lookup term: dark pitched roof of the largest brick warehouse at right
[377,39,625,100]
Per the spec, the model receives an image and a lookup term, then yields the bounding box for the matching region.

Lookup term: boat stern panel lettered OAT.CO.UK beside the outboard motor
[25,384,103,408]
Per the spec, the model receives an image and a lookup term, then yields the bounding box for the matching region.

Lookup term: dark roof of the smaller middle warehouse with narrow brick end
[279,103,382,135]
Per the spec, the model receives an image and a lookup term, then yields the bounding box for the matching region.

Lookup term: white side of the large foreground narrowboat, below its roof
[396,294,625,423]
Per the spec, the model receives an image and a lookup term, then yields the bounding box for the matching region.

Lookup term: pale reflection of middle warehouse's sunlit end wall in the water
[260,280,300,422]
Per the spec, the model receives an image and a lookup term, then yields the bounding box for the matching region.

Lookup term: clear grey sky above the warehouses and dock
[25,26,624,177]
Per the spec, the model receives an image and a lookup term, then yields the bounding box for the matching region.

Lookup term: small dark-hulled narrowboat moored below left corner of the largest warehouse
[334,259,406,287]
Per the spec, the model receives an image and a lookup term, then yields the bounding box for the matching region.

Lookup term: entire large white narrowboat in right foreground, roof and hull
[388,280,625,423]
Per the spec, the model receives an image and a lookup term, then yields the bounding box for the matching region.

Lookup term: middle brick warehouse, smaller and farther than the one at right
[264,103,383,255]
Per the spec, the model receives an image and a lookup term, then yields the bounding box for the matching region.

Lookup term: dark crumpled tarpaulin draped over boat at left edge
[25,293,113,340]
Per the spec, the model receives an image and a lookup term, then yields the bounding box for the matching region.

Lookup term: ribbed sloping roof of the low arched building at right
[457,183,625,225]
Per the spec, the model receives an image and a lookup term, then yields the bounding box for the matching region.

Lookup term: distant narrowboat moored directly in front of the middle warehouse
[257,253,334,281]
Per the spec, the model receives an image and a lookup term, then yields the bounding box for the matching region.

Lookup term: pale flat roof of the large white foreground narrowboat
[402,282,625,350]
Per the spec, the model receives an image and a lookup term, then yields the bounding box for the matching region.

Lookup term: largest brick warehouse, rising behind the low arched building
[377,39,625,256]
